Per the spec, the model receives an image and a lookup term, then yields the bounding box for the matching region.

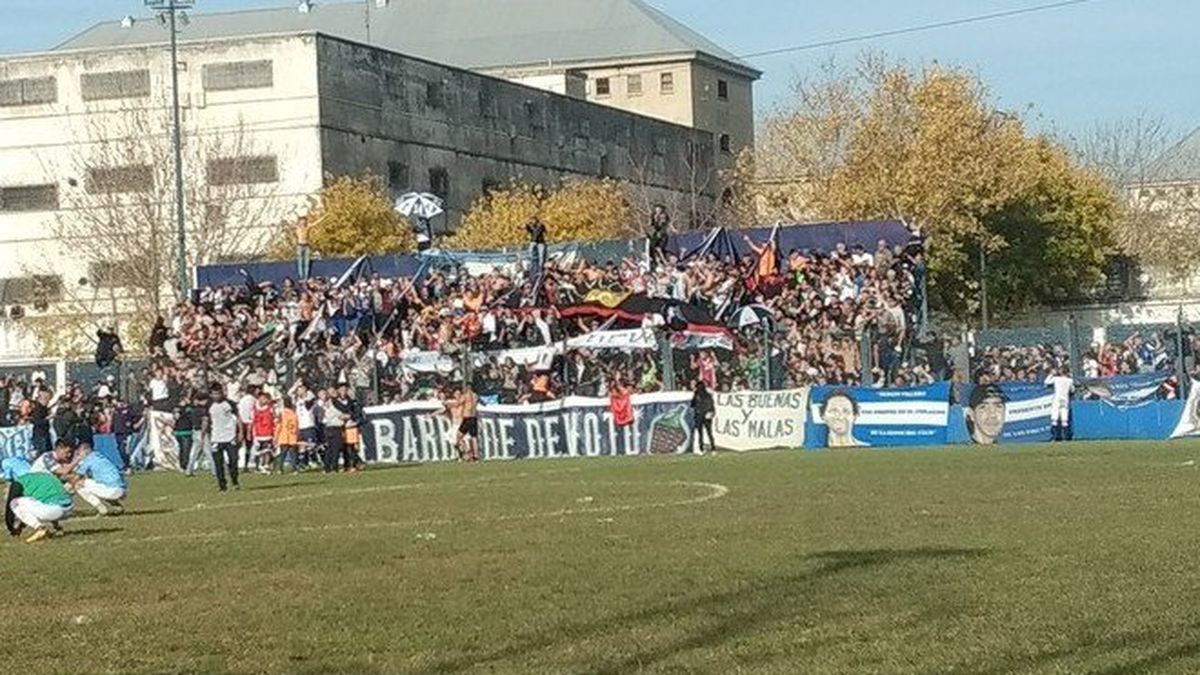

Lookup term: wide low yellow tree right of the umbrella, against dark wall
[446,179,636,250]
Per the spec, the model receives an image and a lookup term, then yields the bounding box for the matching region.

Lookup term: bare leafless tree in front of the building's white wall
[24,104,289,356]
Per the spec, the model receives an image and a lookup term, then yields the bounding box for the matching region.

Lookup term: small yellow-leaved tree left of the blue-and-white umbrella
[272,173,416,259]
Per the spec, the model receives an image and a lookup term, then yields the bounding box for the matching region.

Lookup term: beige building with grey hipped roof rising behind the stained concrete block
[60,0,762,165]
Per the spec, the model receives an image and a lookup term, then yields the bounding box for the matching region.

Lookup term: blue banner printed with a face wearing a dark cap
[962,382,1054,446]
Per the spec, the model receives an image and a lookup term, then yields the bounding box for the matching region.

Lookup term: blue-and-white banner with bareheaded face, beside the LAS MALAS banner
[810,383,950,448]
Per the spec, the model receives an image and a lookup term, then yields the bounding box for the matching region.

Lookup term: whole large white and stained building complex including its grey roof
[0,0,757,358]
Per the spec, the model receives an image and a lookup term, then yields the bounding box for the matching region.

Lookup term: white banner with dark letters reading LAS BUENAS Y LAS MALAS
[713,388,809,452]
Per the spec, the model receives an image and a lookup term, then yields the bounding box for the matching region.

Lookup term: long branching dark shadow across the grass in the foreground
[427,546,989,675]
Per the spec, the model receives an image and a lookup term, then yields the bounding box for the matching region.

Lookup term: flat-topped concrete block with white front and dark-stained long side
[0,1,749,358]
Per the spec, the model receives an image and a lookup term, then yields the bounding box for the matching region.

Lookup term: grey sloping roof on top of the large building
[58,0,757,72]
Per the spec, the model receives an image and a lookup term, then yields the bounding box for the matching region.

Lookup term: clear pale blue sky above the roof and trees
[0,0,1200,133]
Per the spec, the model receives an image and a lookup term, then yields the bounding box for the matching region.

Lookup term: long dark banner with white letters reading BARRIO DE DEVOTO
[364,393,692,464]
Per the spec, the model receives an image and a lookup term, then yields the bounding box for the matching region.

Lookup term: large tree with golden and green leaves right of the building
[755,55,1117,318]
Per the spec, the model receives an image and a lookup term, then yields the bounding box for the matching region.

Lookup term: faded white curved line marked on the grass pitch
[54,480,730,545]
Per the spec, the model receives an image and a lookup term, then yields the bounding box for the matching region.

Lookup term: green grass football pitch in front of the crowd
[7,442,1200,674]
